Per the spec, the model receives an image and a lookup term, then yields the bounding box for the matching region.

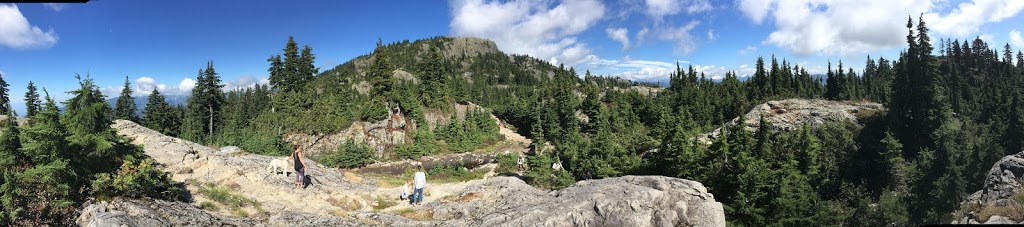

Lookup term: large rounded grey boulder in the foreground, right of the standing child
[434,176,725,227]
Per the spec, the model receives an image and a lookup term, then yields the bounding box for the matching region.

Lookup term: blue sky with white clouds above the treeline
[0,0,1024,112]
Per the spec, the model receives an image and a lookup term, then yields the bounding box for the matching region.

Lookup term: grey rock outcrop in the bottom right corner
[953,151,1024,224]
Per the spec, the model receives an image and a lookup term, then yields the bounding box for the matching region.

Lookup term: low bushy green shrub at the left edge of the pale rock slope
[92,158,184,200]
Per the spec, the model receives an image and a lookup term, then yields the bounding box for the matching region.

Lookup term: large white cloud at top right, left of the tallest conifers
[738,0,933,56]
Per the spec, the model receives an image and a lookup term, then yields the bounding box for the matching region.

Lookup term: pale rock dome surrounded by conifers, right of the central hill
[697,98,886,143]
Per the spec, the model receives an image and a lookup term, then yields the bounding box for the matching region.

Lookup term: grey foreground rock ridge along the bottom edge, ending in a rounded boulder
[78,176,725,227]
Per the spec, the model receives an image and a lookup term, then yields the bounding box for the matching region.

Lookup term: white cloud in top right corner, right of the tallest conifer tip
[925,0,1024,38]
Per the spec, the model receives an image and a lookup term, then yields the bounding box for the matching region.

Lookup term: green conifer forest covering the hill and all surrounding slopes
[0,15,1024,226]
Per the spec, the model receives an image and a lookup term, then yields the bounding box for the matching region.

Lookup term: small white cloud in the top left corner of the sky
[0,4,57,49]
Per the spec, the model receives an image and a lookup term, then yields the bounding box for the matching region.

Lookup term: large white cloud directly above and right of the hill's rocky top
[450,0,605,65]
